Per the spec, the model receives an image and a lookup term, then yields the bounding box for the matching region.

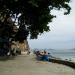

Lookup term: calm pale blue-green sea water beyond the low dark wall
[47,50,75,62]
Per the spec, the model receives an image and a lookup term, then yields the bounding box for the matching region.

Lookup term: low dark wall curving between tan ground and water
[49,59,75,69]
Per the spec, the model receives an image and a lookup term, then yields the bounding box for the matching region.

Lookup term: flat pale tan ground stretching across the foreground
[0,55,75,75]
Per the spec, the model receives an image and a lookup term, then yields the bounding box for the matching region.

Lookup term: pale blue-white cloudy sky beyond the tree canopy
[28,0,75,49]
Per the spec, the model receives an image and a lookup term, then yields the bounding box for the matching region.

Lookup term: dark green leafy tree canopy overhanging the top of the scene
[0,0,71,40]
